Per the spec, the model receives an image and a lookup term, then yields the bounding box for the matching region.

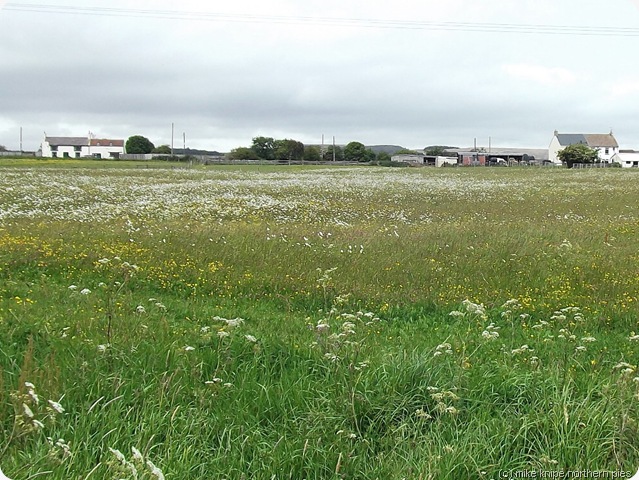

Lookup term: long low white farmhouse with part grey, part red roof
[41,136,124,158]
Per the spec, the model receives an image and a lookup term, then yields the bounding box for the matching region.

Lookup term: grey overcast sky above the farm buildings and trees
[0,0,639,152]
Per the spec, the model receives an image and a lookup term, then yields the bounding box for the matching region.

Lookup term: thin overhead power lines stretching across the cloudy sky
[4,3,639,37]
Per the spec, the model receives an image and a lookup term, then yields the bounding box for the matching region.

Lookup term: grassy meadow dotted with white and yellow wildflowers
[0,160,639,480]
